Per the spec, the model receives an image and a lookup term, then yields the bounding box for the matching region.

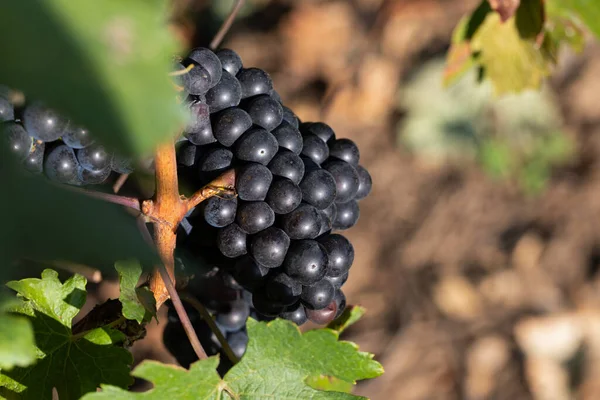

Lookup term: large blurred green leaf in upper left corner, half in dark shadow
[0,0,184,155]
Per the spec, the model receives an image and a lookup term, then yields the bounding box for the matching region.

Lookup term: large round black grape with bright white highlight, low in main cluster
[283,240,328,285]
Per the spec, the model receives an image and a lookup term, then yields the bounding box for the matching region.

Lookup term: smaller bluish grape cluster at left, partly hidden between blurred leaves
[0,87,133,186]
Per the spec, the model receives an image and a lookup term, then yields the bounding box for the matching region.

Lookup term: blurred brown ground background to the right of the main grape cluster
[91,0,600,400]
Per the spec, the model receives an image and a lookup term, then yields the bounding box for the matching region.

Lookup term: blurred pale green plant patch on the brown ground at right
[398,61,573,194]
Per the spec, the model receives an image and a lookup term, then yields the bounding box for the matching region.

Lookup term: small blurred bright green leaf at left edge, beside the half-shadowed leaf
[0,299,36,370]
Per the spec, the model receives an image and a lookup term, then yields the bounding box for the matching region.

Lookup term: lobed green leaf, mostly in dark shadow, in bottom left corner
[0,269,133,400]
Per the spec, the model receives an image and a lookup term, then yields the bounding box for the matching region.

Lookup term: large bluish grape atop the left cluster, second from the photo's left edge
[23,103,68,142]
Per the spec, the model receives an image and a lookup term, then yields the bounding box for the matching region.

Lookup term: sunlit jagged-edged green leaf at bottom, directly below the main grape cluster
[83,319,383,400]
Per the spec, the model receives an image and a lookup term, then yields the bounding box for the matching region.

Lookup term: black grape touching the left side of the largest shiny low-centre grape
[250,226,290,268]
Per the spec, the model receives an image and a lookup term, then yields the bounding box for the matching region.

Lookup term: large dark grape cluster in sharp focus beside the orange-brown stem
[170,48,371,325]
